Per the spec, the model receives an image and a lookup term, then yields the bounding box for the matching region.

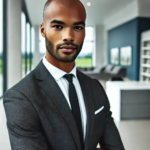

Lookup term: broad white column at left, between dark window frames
[7,0,22,88]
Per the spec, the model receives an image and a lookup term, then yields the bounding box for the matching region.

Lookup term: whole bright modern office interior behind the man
[0,0,150,150]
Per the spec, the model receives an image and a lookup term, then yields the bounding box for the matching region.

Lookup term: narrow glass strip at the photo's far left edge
[0,0,3,97]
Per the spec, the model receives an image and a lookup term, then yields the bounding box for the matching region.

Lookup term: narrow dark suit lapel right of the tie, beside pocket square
[77,71,94,150]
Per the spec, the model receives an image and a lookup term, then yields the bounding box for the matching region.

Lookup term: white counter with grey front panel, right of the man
[106,81,150,122]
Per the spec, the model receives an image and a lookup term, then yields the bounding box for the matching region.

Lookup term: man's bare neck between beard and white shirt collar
[46,53,75,73]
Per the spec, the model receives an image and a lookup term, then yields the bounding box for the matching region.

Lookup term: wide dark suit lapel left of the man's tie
[36,62,81,150]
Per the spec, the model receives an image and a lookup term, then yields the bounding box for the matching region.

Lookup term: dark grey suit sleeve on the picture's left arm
[4,90,48,150]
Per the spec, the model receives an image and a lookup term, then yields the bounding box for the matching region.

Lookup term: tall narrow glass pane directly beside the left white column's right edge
[21,12,26,77]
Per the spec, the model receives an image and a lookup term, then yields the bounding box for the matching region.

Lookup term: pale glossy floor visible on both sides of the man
[0,100,150,150]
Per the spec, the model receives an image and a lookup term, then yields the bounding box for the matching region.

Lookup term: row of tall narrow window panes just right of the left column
[21,3,34,77]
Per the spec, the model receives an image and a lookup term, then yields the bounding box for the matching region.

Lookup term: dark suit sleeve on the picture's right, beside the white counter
[97,81,125,150]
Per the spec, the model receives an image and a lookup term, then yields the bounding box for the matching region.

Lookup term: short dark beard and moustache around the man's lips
[45,34,83,62]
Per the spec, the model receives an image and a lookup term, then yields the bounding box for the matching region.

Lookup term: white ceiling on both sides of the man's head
[25,0,135,25]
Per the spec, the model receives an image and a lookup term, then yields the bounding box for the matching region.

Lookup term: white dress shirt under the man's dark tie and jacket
[42,56,87,141]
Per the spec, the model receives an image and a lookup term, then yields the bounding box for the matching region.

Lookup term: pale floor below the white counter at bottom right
[116,120,150,150]
